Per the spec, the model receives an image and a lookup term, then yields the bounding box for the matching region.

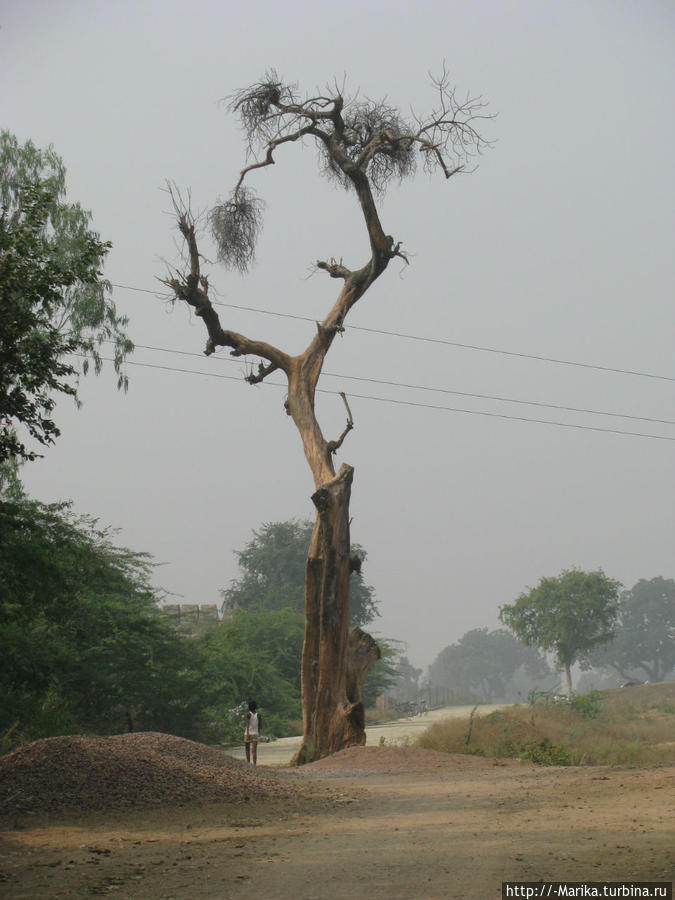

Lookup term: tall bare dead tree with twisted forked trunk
[162,71,490,764]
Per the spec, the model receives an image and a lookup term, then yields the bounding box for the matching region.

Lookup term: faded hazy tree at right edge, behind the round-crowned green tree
[584,576,675,682]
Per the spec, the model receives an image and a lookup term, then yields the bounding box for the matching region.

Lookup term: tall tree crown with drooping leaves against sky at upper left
[0,131,133,462]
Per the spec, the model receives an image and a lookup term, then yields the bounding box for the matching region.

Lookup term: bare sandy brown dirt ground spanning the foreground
[0,747,675,900]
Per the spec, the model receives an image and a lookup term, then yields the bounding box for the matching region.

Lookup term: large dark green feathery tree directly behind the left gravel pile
[0,494,206,739]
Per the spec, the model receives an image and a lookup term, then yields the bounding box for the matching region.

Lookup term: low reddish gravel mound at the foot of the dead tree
[296,747,519,778]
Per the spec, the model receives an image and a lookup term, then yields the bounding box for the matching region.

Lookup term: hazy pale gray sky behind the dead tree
[0,0,675,666]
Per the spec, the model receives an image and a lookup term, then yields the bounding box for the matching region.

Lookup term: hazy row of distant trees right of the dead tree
[420,569,675,703]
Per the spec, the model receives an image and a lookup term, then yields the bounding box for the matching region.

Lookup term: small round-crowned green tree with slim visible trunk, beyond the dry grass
[499,569,620,696]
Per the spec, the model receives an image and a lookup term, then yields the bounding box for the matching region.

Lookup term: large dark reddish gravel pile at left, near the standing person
[0,732,312,813]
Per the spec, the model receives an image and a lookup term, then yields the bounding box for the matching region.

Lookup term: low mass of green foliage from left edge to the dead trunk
[0,500,390,750]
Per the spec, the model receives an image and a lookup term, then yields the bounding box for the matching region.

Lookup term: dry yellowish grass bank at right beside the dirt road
[418,683,675,765]
